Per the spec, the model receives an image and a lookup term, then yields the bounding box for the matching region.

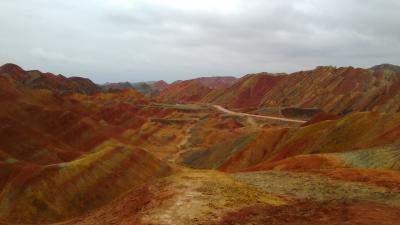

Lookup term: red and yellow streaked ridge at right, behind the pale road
[206,67,400,114]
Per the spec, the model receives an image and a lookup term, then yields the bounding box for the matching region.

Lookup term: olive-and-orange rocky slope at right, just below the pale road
[216,112,400,171]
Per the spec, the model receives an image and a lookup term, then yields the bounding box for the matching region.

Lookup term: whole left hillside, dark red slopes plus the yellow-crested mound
[0,69,172,224]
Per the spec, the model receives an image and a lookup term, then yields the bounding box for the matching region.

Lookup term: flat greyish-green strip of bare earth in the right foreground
[234,171,400,207]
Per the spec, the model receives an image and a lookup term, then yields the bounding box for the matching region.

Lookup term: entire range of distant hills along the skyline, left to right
[0,64,400,114]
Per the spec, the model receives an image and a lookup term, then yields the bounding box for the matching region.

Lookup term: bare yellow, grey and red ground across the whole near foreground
[54,169,400,225]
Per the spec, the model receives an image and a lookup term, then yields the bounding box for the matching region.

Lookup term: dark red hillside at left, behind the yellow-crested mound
[0,76,147,164]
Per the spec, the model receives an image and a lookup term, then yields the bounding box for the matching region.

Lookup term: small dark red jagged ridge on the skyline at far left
[0,64,100,94]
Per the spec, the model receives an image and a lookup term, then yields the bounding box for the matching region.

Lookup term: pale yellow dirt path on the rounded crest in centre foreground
[63,169,287,225]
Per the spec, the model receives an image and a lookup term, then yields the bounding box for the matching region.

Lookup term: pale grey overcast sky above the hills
[0,0,400,83]
